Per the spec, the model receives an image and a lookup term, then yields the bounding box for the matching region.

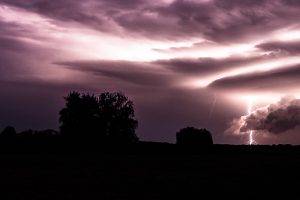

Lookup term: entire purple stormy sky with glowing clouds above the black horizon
[0,0,300,144]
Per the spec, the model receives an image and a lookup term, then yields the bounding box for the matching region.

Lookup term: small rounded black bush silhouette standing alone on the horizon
[176,127,213,146]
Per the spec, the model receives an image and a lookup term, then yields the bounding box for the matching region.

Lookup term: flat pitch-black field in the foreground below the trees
[0,144,300,200]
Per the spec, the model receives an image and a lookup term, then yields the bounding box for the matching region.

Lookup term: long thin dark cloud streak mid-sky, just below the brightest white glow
[57,55,275,83]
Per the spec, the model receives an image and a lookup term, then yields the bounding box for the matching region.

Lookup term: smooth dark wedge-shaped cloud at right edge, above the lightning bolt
[209,65,300,91]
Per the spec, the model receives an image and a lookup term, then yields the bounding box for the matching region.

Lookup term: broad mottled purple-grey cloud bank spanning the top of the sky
[1,0,300,42]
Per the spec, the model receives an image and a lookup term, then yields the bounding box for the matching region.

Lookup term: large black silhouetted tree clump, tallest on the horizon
[59,92,138,143]
